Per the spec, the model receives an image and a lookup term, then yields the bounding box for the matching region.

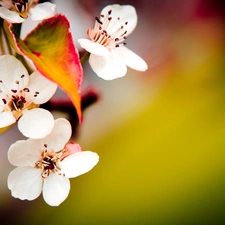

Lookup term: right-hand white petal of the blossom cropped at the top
[30,2,56,20]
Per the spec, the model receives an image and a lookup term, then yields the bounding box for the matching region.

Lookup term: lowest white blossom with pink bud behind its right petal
[8,118,99,206]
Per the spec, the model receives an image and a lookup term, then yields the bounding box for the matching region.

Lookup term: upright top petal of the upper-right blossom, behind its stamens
[101,4,137,35]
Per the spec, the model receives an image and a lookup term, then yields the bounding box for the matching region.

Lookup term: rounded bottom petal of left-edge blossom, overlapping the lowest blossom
[18,108,54,139]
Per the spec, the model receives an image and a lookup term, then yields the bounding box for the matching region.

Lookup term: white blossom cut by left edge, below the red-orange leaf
[0,55,57,138]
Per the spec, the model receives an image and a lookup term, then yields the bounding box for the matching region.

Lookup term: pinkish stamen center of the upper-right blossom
[87,10,128,49]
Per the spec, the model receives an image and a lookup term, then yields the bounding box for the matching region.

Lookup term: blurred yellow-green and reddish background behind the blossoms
[0,0,225,225]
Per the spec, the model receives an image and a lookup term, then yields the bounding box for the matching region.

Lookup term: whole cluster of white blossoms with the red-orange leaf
[0,0,147,206]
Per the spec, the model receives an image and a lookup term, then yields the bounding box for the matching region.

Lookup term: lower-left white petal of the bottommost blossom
[8,167,42,200]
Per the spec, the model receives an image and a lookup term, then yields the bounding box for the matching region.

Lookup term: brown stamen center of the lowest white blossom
[35,144,68,179]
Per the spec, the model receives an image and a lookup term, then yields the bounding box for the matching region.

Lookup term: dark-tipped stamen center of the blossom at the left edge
[0,75,39,119]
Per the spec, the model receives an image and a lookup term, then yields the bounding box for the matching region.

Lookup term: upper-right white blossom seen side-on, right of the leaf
[78,5,148,80]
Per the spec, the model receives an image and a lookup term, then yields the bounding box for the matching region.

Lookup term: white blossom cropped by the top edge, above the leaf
[0,0,56,23]
